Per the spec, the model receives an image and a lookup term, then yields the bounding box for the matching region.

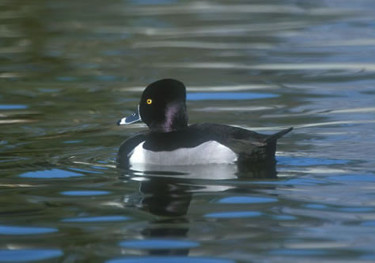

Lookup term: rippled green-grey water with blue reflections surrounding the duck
[0,0,375,263]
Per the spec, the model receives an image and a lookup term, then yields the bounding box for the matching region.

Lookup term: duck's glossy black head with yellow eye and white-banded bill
[118,79,188,132]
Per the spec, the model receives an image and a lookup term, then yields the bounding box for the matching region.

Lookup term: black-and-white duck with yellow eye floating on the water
[116,79,293,172]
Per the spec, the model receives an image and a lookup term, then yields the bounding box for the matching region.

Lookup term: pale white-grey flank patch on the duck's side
[129,141,237,166]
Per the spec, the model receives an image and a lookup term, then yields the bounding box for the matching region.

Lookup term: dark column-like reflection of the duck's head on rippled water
[132,177,195,256]
